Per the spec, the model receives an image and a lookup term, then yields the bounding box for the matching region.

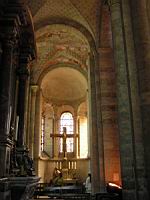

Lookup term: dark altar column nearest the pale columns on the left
[17,56,29,147]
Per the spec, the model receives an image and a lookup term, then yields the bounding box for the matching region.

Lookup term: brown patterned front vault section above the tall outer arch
[28,0,101,37]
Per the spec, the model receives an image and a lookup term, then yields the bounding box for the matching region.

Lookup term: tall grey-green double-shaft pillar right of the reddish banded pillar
[109,0,148,200]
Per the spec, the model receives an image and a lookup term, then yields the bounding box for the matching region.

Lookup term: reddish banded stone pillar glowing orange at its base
[99,1,121,184]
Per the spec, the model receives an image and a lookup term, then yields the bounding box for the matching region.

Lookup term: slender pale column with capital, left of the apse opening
[29,85,38,158]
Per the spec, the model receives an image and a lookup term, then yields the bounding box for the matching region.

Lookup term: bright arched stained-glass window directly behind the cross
[60,112,74,152]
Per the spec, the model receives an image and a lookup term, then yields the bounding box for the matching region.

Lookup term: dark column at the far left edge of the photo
[0,37,14,177]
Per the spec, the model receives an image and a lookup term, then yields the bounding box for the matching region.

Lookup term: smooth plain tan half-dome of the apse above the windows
[41,67,87,105]
